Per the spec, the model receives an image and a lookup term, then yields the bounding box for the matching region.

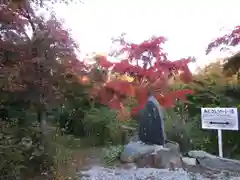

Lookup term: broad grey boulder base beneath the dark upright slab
[120,141,183,169]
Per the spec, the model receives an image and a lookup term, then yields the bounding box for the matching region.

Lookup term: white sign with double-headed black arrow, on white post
[201,108,239,157]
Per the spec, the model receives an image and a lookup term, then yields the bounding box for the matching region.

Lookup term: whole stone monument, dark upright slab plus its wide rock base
[120,94,183,169]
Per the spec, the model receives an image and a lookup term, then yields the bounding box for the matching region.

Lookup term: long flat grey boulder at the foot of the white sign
[188,151,240,172]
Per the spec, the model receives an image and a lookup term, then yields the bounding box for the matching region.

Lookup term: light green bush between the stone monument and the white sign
[165,104,214,153]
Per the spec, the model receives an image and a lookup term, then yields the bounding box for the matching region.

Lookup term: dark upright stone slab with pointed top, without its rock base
[137,96,165,146]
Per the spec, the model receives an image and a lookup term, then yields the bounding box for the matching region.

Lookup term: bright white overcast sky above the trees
[52,0,240,69]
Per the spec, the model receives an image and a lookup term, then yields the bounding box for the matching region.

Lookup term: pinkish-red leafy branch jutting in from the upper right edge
[206,26,240,54]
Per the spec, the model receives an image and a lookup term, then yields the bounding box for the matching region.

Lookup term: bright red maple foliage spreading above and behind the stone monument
[89,37,193,119]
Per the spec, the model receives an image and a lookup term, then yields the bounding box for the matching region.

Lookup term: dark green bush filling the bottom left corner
[0,121,53,180]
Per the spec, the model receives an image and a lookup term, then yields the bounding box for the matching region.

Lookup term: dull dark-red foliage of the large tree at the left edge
[0,4,87,104]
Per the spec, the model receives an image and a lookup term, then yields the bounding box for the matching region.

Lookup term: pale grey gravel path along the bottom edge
[79,167,240,180]
